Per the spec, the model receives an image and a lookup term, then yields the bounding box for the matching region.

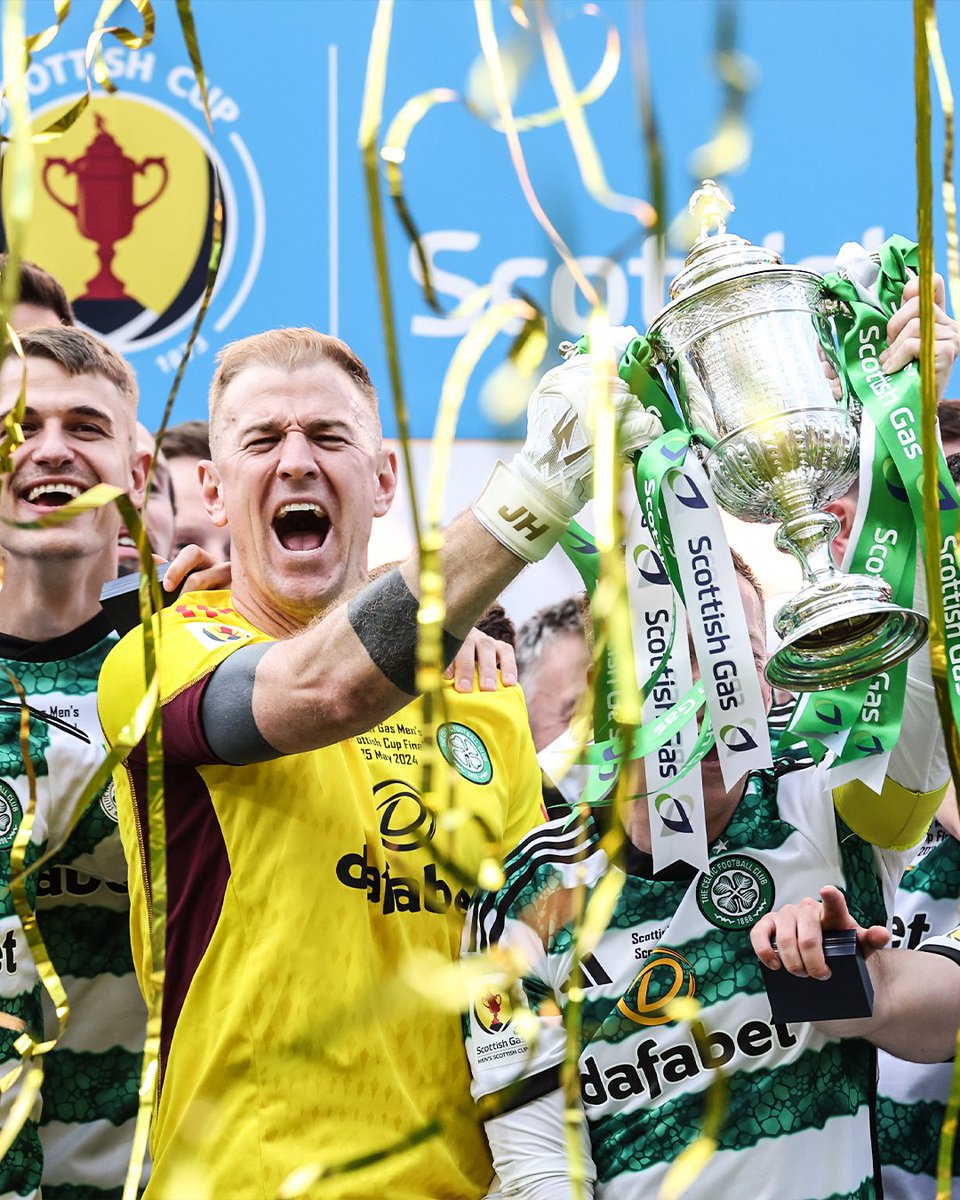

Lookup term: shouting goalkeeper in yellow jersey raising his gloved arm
[95,329,659,1200]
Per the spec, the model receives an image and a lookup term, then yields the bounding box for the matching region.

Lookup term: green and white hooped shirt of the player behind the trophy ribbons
[466,768,910,1200]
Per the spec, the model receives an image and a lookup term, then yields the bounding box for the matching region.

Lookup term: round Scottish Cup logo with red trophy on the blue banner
[0,59,266,373]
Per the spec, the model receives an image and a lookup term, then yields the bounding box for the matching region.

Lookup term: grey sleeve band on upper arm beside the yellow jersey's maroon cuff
[200,642,281,767]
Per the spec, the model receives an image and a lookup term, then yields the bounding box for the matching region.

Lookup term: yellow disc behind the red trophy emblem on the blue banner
[10,95,210,313]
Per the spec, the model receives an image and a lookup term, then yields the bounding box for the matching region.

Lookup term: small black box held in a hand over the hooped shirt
[760,929,874,1024]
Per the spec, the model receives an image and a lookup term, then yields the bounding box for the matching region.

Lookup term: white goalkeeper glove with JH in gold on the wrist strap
[473,325,664,563]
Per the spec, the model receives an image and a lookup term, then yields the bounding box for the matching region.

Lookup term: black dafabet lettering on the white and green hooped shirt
[580,1021,797,1105]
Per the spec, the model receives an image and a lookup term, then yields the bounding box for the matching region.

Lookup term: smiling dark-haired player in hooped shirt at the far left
[0,326,149,1200]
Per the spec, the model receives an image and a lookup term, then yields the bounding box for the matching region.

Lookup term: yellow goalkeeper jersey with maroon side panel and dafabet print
[100,592,540,1200]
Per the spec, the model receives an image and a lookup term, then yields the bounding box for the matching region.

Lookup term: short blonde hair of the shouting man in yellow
[209,326,382,456]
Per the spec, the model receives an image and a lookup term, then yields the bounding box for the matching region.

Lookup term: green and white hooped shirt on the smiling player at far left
[0,613,146,1200]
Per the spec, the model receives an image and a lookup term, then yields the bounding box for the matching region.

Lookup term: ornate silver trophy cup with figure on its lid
[649,180,926,691]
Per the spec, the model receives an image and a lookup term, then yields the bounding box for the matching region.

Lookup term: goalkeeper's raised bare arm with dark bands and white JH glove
[203,340,660,762]
